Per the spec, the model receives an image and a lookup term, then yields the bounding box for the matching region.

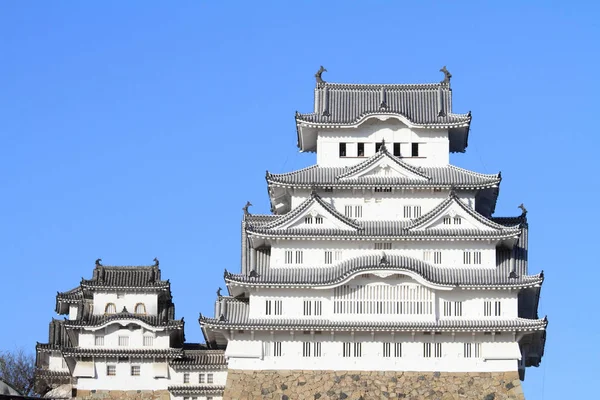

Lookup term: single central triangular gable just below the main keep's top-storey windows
[337,145,431,182]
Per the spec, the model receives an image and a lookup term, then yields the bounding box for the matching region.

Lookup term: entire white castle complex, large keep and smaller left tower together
[36,67,548,400]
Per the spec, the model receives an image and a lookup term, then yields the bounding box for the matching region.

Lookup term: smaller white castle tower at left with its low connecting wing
[36,259,227,400]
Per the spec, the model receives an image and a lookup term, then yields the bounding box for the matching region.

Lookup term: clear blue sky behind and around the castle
[0,1,600,400]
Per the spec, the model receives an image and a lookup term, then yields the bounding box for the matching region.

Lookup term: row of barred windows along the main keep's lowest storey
[270,342,481,360]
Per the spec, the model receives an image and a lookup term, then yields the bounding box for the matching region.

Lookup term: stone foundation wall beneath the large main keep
[223,370,524,400]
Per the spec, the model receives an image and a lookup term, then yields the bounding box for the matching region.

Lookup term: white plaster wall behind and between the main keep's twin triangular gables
[291,188,475,221]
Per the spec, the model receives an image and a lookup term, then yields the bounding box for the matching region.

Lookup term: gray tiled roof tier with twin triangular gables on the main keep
[246,192,521,240]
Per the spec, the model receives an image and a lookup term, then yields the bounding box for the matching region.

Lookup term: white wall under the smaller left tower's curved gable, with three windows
[79,321,170,349]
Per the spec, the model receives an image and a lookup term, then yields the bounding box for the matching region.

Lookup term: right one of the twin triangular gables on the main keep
[407,192,519,232]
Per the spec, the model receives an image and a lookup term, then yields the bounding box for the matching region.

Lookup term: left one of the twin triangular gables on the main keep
[255,192,360,231]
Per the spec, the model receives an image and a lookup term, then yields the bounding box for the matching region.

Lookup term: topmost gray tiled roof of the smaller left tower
[81,266,169,289]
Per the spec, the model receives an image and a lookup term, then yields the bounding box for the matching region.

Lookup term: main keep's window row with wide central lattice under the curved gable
[266,300,502,318]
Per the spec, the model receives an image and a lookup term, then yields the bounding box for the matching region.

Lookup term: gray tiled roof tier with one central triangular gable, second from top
[266,150,502,189]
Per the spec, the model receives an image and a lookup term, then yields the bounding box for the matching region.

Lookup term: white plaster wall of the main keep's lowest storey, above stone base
[229,332,517,372]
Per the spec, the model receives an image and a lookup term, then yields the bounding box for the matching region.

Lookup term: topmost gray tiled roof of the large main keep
[296,83,471,127]
